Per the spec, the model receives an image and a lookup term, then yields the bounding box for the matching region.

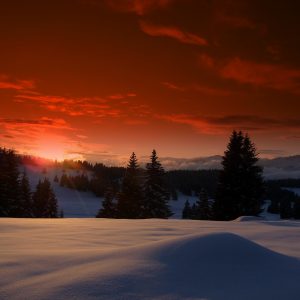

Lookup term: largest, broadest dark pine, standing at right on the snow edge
[214,131,263,220]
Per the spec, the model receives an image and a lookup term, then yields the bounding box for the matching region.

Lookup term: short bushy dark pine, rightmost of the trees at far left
[32,178,58,218]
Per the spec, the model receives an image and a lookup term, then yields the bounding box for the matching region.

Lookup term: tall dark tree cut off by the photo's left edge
[0,148,20,217]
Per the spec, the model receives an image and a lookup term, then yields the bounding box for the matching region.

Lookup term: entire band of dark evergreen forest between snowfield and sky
[0,131,300,220]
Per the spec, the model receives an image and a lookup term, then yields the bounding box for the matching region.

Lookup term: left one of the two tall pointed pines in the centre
[117,152,143,219]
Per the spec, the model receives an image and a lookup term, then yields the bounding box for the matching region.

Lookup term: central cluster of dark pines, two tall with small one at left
[97,150,172,219]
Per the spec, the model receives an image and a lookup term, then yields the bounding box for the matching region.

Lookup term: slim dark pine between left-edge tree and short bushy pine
[18,172,32,218]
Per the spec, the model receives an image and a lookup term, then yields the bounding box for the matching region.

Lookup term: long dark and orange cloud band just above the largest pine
[157,114,300,134]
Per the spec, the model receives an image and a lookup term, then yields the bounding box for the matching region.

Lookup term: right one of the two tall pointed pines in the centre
[143,150,172,219]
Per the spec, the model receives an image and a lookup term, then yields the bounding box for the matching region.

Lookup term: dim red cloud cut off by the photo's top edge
[106,0,174,16]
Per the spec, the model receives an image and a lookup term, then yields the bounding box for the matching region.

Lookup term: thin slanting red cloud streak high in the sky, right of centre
[140,21,208,46]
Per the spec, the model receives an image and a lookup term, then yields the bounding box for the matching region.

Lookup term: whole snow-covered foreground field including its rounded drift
[0,218,300,300]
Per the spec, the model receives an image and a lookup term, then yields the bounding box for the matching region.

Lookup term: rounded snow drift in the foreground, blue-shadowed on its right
[0,232,300,300]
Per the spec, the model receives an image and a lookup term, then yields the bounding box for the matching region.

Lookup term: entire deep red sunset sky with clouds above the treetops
[0,0,300,164]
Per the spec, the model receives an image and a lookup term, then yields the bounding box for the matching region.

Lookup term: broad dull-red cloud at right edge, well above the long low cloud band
[219,57,300,94]
